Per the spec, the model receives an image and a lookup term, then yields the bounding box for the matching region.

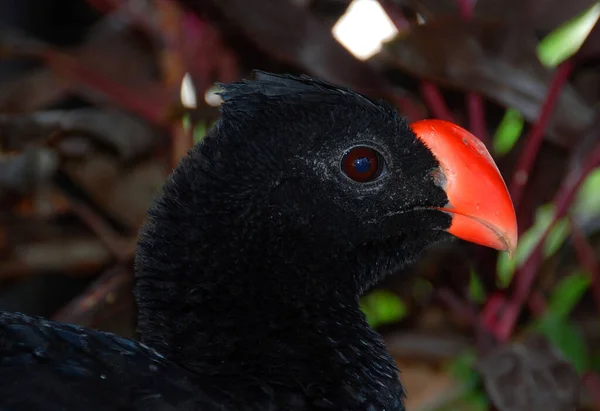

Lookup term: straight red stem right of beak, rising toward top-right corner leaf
[510,60,574,209]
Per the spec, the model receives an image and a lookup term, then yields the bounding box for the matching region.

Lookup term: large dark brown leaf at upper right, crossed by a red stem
[386,16,594,147]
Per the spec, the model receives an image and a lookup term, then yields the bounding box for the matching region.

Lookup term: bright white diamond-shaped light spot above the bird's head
[332,0,398,60]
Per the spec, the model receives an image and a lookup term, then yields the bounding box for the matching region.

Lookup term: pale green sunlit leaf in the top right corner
[537,3,600,67]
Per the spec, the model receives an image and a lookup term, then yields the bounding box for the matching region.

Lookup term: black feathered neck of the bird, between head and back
[135,142,403,410]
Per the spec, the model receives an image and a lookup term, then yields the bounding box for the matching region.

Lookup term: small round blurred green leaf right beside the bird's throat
[361,290,408,327]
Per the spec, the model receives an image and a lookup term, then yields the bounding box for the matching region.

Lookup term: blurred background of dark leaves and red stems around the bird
[0,0,600,411]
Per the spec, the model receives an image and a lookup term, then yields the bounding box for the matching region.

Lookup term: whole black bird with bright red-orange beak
[0,73,517,411]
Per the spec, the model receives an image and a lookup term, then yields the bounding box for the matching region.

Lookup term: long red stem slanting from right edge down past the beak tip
[494,140,600,340]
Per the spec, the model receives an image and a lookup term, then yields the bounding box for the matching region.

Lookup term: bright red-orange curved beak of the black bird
[411,120,517,255]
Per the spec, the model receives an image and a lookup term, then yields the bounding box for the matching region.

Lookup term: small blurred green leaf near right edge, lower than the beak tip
[547,272,591,318]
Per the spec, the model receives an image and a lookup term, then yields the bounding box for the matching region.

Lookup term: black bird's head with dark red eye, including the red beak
[163,72,517,292]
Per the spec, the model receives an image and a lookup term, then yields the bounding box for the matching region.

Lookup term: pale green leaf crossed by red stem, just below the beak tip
[496,204,570,288]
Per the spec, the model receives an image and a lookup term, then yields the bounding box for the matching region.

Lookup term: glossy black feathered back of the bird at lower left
[0,313,225,411]
